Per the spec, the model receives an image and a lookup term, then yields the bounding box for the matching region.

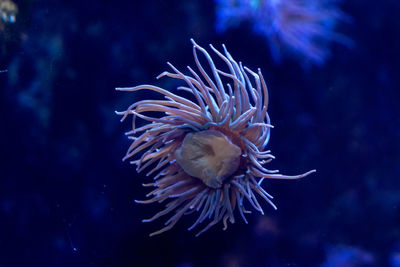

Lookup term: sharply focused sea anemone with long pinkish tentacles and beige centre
[116,40,315,236]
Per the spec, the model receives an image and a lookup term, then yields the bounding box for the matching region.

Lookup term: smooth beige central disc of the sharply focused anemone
[174,130,242,188]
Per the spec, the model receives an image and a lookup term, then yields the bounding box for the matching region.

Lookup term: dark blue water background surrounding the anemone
[0,0,400,267]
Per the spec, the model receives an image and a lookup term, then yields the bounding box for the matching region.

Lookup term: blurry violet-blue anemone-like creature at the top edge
[216,0,352,65]
